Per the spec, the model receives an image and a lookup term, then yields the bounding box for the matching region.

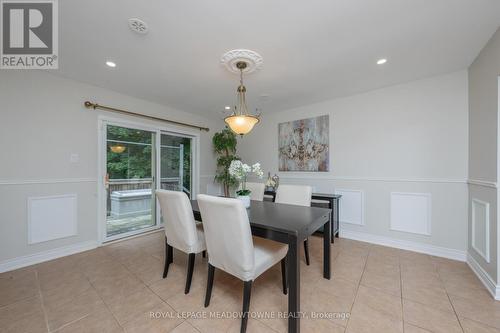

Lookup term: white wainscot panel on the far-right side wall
[471,199,490,263]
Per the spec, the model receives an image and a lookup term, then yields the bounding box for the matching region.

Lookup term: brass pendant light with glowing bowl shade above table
[224,61,260,136]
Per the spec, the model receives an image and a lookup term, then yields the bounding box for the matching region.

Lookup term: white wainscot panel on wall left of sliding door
[28,194,77,244]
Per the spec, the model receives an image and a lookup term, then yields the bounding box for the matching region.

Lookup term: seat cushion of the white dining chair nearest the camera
[252,236,288,281]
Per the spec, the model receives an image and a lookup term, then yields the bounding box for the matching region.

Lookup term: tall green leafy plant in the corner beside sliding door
[212,127,239,197]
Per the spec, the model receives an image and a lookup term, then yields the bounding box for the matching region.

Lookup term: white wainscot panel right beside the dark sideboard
[335,189,365,225]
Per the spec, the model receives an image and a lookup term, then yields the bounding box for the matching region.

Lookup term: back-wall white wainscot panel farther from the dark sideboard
[390,192,432,236]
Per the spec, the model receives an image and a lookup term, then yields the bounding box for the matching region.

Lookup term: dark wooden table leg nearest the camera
[287,235,302,333]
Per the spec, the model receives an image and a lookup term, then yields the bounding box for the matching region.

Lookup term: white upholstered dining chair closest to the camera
[197,194,288,332]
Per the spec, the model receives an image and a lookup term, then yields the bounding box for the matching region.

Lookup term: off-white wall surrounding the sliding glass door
[0,70,221,270]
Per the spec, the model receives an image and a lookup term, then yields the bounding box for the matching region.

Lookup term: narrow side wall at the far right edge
[468,26,500,298]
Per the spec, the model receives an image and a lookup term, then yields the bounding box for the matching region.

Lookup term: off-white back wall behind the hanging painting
[238,71,468,260]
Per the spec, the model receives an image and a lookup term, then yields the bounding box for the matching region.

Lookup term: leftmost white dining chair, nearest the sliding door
[156,190,207,294]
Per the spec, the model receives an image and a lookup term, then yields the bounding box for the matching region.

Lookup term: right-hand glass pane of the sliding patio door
[160,134,192,198]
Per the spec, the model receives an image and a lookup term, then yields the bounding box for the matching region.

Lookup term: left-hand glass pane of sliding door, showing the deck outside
[106,125,156,237]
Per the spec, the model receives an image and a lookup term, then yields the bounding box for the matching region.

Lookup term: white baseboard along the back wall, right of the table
[340,228,467,261]
